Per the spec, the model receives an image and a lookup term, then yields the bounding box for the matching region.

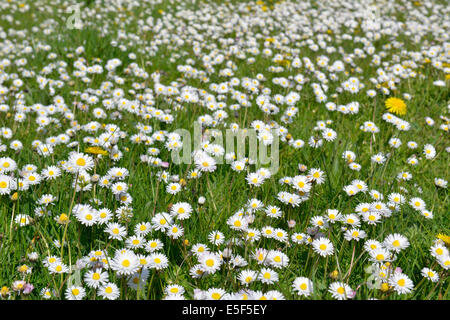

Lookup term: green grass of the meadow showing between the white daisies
[0,1,450,300]
